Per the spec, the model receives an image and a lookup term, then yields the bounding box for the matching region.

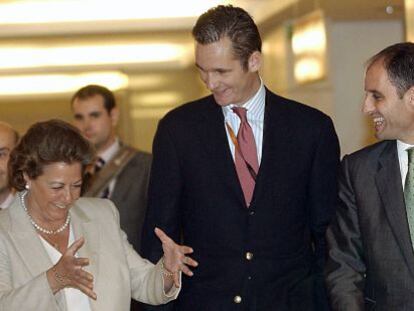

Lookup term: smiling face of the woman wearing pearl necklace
[24,162,82,223]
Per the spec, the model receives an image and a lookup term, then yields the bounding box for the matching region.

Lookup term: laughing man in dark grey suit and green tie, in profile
[327,43,414,311]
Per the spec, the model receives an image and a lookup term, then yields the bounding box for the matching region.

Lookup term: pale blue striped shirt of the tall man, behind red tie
[222,79,266,165]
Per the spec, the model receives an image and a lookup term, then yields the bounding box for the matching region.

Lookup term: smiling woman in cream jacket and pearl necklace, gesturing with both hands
[0,120,196,311]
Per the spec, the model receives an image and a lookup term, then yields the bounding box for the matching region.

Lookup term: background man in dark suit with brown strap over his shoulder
[71,85,151,310]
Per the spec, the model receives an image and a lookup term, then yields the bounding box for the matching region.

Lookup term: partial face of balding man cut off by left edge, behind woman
[0,124,16,193]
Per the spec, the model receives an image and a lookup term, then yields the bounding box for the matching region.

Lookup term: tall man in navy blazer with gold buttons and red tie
[143,6,339,311]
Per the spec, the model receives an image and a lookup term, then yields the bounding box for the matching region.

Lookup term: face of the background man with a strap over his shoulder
[72,95,118,152]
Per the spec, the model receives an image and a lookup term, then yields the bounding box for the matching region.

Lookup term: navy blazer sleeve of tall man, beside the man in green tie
[309,118,339,310]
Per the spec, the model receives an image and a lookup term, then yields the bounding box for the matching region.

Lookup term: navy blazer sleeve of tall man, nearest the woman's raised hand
[141,120,182,311]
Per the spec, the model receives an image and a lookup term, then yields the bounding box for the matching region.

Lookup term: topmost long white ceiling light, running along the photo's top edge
[0,0,223,24]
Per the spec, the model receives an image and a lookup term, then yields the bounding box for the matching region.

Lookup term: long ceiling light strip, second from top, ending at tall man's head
[0,43,192,70]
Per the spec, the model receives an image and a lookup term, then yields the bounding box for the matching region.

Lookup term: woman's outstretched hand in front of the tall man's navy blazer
[155,228,198,287]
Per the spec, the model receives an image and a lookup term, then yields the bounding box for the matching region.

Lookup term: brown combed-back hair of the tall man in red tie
[192,5,262,69]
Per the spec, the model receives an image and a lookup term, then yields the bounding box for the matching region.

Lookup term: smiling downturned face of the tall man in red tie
[195,37,261,106]
